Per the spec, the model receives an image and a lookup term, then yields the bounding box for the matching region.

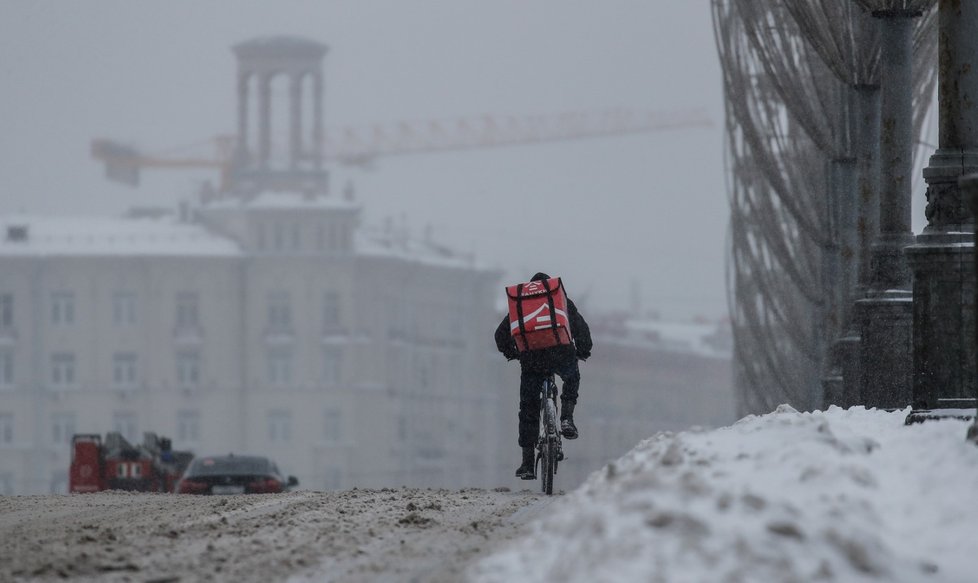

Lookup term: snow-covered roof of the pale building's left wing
[0,215,241,256]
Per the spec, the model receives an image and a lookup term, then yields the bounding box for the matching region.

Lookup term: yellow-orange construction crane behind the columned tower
[91,109,713,191]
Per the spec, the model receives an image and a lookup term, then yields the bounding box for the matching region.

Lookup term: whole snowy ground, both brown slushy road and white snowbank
[0,406,978,583]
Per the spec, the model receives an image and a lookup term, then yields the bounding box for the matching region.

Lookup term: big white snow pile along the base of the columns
[470,405,978,583]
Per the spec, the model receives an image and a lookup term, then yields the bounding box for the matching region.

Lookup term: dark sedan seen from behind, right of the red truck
[176,454,299,494]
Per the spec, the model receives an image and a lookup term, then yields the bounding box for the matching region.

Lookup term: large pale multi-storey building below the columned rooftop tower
[0,193,501,493]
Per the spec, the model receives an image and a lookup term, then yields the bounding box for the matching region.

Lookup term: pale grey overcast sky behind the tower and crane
[0,0,728,319]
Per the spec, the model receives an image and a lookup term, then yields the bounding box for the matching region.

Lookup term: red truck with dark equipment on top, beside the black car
[68,432,194,493]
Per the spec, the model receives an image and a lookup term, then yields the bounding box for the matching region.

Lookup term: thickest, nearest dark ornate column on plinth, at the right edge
[907,0,978,410]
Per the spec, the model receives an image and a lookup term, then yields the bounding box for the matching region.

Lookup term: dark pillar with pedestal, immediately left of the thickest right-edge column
[856,10,921,408]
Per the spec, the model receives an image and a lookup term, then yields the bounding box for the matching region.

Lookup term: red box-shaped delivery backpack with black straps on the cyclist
[506,277,571,352]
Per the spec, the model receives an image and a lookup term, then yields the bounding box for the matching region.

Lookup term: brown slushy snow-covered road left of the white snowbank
[0,489,552,583]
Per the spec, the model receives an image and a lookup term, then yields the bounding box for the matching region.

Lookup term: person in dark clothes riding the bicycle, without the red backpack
[496,273,591,480]
